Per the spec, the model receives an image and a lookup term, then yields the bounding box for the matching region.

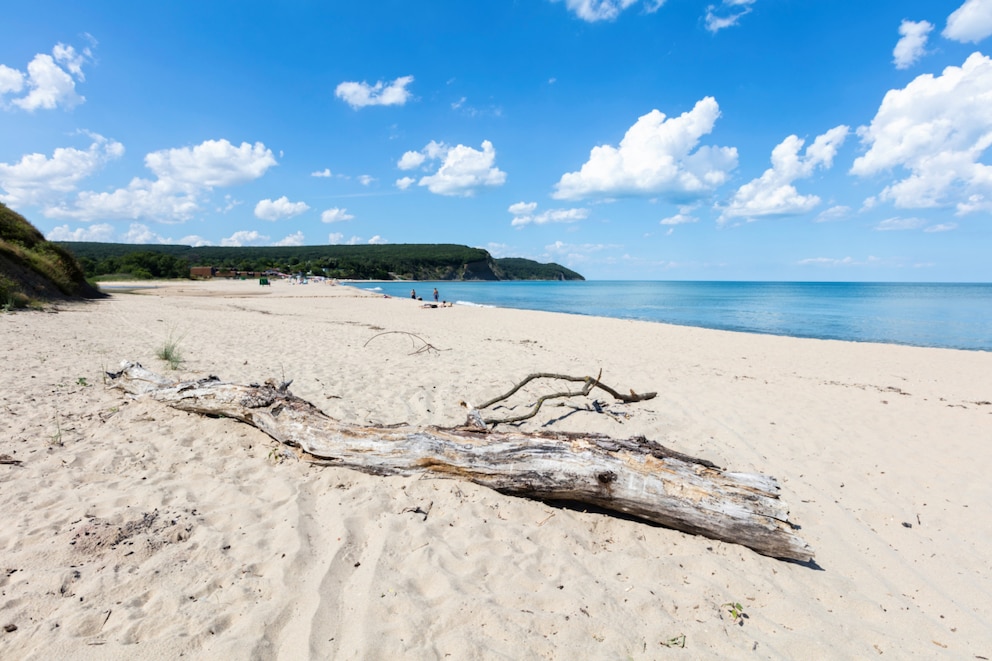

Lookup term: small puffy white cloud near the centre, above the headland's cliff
[396,140,506,197]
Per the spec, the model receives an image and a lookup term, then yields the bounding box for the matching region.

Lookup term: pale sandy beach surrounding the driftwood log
[0,281,992,660]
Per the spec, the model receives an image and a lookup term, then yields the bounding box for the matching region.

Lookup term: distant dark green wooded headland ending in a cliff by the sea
[61,243,583,280]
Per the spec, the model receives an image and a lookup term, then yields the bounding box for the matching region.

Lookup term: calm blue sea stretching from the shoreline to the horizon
[358,280,992,351]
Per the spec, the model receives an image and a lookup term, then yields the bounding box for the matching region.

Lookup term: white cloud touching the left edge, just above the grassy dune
[0,133,124,207]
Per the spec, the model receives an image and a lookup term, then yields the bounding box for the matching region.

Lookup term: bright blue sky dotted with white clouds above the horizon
[0,0,992,281]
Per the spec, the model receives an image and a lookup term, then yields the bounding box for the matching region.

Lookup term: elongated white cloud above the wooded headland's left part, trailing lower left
[43,140,276,222]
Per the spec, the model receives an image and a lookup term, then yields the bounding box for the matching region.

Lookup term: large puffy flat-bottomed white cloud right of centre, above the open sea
[552,97,737,200]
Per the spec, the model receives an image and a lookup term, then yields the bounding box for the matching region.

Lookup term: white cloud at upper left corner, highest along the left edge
[0,43,92,112]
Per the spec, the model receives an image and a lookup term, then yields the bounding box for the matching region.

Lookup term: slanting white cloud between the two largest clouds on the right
[720,125,850,221]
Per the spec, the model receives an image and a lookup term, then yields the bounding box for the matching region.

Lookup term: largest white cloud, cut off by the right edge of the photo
[851,53,992,214]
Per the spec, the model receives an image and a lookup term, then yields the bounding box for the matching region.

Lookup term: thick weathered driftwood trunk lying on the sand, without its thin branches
[110,363,813,562]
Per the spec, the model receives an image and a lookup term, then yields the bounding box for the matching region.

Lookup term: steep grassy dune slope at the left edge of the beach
[0,203,101,310]
